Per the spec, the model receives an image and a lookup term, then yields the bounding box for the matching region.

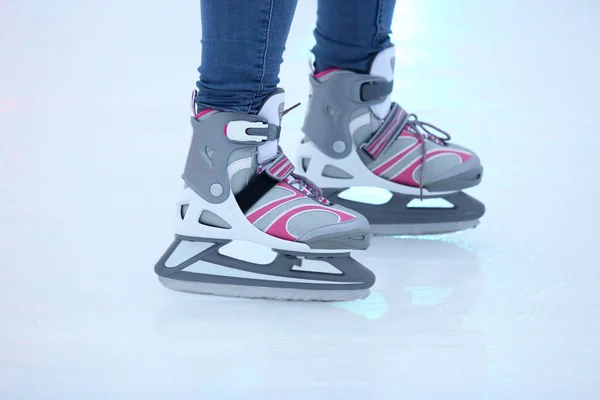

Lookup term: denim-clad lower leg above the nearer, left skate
[196,0,298,113]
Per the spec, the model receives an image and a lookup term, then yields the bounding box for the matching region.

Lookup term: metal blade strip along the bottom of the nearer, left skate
[158,276,370,302]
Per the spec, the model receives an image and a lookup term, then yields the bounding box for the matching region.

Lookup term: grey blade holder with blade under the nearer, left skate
[154,235,375,301]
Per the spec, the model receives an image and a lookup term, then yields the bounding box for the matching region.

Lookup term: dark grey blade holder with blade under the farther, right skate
[323,188,485,236]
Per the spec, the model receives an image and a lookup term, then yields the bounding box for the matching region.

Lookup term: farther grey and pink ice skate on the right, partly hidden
[297,47,485,235]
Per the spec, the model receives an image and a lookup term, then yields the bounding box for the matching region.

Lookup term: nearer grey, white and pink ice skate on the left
[155,90,375,301]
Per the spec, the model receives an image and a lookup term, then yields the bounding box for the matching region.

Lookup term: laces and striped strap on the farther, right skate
[361,103,452,200]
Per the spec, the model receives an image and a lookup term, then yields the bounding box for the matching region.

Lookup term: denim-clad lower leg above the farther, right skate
[313,0,396,73]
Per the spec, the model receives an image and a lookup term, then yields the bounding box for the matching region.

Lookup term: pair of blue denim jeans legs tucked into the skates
[196,0,396,113]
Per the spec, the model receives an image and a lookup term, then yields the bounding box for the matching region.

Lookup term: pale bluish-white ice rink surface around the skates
[0,0,600,400]
